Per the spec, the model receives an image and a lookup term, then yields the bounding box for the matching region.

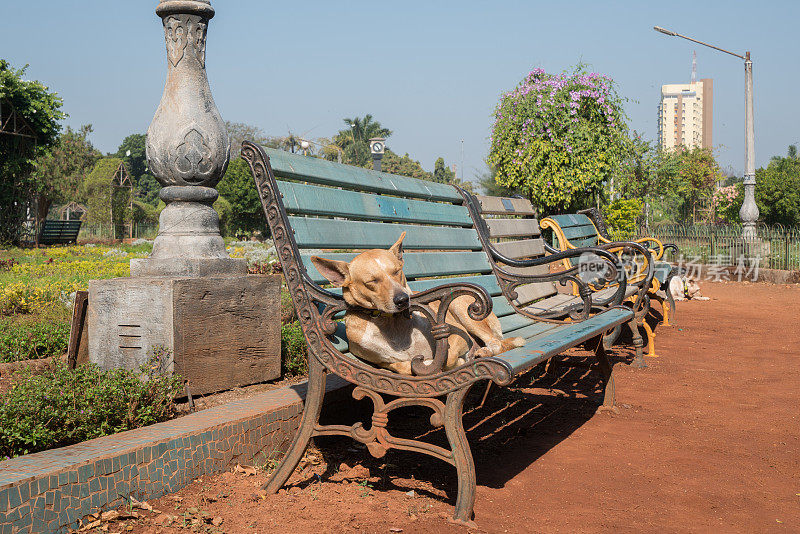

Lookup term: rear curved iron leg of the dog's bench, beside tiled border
[264,354,325,493]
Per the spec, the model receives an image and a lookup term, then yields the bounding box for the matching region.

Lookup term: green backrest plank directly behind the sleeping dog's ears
[301,252,492,284]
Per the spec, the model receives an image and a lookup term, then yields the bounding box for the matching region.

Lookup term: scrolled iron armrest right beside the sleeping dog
[409,283,492,376]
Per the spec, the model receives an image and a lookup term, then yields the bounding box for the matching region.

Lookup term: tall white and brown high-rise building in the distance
[658,78,714,149]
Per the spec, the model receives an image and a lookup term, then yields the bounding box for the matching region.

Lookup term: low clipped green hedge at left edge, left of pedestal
[0,317,69,362]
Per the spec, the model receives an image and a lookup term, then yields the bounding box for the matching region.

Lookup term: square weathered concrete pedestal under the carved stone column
[87,275,281,394]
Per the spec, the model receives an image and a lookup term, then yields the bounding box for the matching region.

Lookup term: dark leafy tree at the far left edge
[0,59,66,243]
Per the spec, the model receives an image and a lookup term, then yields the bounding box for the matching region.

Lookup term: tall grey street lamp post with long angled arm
[653,26,758,241]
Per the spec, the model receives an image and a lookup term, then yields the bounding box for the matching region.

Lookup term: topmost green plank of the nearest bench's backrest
[264,147,463,204]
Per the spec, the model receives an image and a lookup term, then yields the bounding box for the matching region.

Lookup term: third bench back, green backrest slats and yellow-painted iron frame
[541,212,677,357]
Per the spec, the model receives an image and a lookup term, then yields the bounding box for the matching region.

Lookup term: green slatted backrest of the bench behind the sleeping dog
[250,148,530,336]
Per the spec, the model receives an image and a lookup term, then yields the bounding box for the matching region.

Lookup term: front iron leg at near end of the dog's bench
[444,387,476,528]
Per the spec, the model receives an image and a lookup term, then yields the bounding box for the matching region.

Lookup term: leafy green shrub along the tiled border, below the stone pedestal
[0,350,182,456]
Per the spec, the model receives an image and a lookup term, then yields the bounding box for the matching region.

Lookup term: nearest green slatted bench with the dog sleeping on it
[242,142,633,524]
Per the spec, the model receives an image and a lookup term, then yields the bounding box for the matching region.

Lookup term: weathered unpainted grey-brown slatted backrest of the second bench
[475,195,558,305]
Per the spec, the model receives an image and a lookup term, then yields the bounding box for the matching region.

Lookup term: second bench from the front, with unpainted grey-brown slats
[460,195,653,366]
